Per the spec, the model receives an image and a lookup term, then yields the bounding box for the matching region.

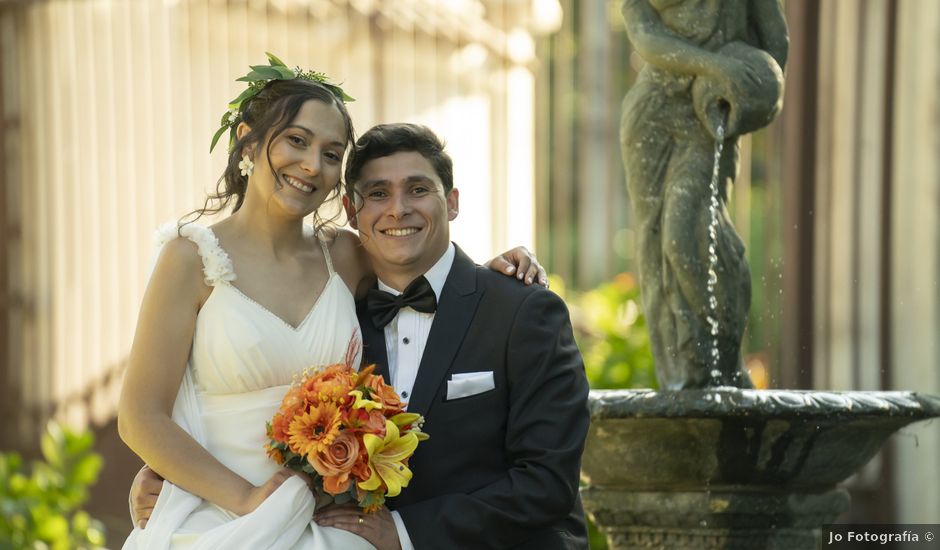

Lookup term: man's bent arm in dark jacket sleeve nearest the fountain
[397,290,589,549]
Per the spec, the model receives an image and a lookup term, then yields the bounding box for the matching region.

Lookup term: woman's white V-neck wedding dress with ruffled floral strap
[124,223,373,550]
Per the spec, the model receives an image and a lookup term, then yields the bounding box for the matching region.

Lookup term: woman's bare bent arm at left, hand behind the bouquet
[118,239,289,514]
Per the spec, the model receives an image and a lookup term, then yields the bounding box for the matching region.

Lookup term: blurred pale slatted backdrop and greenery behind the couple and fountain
[0,0,940,546]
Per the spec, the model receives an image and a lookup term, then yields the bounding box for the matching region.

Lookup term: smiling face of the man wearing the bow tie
[346,151,458,284]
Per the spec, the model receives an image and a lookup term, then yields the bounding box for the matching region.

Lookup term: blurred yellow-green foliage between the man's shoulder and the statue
[550,273,656,389]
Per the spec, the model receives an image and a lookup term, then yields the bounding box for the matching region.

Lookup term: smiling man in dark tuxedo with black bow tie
[317,124,589,550]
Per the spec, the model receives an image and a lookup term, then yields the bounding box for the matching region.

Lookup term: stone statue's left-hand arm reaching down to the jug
[620,0,724,76]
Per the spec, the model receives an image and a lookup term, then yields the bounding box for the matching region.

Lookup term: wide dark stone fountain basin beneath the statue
[581,388,940,550]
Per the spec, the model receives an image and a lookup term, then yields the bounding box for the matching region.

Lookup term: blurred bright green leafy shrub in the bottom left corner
[0,422,105,550]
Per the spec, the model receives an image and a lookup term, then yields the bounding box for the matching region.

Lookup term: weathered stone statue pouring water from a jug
[621,0,789,389]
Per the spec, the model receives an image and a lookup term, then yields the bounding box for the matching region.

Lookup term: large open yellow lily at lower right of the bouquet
[359,420,418,497]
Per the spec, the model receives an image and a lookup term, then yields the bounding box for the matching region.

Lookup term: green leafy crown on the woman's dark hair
[209,52,355,153]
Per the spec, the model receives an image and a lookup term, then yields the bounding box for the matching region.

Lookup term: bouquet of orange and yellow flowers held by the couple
[265,338,428,512]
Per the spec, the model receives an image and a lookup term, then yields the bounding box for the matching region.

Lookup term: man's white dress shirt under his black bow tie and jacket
[378,243,456,550]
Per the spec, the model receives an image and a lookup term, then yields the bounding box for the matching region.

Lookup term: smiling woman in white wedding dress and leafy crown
[118,56,538,549]
